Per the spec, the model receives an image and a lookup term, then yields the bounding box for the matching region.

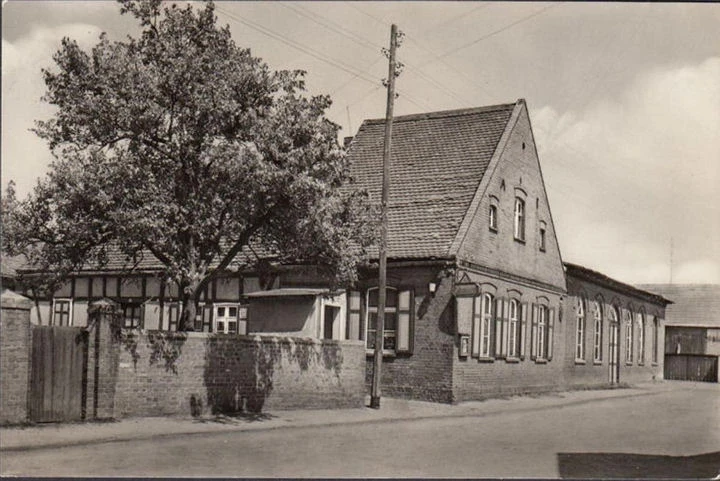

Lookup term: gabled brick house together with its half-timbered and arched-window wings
[12,100,666,402]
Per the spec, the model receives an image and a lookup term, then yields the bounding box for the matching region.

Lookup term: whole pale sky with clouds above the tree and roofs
[2,0,720,284]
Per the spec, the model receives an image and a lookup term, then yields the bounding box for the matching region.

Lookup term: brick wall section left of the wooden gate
[0,290,32,424]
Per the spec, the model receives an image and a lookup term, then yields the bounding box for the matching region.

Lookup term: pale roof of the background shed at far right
[638,284,720,327]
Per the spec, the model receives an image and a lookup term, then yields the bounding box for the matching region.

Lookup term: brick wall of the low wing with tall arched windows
[564,275,665,386]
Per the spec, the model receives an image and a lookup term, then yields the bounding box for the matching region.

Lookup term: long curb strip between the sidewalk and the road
[0,389,668,453]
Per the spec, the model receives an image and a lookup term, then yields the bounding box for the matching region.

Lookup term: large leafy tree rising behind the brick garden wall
[4,0,374,326]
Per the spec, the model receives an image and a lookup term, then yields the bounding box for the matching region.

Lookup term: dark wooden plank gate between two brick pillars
[28,326,88,422]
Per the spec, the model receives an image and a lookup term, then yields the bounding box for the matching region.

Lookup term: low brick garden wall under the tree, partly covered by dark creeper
[115,331,365,417]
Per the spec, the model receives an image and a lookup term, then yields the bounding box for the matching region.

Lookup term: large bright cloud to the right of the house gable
[532,57,720,282]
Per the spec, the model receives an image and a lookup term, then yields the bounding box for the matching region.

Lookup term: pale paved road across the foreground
[1,383,720,478]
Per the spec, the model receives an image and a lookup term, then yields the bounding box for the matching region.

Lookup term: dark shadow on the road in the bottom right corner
[557,451,720,479]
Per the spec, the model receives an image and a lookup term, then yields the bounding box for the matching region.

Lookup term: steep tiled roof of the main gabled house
[348,103,517,259]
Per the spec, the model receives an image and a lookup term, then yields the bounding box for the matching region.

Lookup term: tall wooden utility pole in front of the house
[370,24,399,409]
